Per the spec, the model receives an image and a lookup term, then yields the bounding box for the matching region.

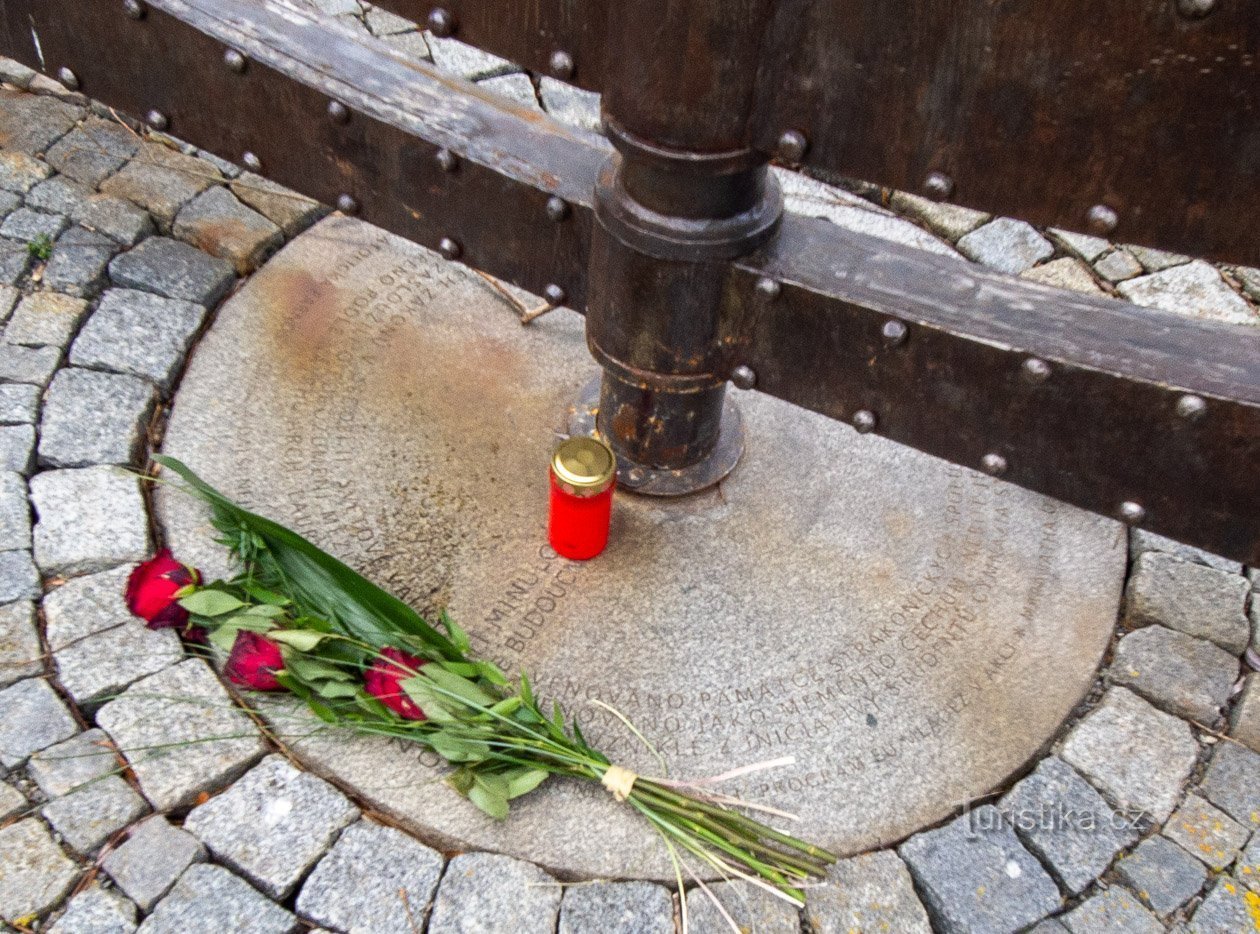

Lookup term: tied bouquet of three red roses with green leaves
[127,456,835,904]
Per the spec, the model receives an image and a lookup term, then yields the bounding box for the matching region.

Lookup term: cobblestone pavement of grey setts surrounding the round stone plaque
[0,0,1260,934]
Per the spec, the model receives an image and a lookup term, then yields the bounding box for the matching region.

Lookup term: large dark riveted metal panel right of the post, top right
[751,0,1260,265]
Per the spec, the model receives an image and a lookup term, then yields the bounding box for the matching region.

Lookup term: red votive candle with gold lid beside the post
[547,437,617,561]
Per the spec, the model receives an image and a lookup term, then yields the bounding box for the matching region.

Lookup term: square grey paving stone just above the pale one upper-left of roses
[39,367,156,468]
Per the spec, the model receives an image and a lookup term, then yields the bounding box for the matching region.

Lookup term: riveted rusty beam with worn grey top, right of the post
[726,217,1260,565]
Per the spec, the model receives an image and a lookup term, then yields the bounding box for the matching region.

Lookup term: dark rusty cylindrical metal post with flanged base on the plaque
[578,0,782,495]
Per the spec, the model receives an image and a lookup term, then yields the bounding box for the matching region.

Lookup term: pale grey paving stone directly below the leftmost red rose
[54,619,184,708]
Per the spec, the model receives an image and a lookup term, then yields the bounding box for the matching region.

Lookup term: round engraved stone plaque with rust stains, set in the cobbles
[161,218,1125,877]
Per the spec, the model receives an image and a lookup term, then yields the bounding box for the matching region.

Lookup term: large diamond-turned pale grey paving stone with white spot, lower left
[184,755,359,900]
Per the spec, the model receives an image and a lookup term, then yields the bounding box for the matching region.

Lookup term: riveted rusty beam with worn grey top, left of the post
[0,0,610,306]
